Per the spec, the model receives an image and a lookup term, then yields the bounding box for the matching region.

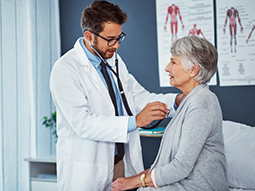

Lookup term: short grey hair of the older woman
[171,36,218,84]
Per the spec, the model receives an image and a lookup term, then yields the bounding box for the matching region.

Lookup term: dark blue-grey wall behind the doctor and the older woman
[59,0,255,167]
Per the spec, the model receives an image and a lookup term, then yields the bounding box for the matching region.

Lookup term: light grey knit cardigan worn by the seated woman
[140,84,229,191]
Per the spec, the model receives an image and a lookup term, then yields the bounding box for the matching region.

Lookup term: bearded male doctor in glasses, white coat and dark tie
[50,1,182,191]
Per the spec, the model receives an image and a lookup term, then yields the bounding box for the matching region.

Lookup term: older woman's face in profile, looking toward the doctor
[165,55,192,91]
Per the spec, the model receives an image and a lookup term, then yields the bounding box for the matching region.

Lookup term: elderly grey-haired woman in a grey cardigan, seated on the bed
[112,36,229,191]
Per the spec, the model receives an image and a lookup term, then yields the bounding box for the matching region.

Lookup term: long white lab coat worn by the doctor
[50,39,176,191]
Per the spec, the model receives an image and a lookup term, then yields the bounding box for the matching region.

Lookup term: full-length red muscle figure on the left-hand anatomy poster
[164,4,184,41]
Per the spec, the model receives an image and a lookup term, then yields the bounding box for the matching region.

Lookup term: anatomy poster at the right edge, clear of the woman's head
[216,0,255,86]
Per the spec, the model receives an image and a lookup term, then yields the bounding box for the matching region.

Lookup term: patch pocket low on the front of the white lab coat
[70,161,105,191]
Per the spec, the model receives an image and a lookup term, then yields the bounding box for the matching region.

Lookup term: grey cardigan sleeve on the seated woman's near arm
[155,108,214,186]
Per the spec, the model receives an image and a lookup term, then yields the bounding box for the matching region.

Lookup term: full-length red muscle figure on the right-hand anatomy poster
[223,7,243,52]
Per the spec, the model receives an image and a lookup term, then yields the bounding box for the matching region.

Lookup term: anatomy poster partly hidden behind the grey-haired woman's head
[156,0,216,87]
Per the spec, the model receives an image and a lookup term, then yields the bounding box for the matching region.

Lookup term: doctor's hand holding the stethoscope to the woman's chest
[136,101,168,128]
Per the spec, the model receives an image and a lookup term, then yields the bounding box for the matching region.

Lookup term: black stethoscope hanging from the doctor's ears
[89,40,170,129]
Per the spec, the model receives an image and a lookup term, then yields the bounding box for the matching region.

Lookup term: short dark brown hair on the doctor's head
[81,0,127,33]
